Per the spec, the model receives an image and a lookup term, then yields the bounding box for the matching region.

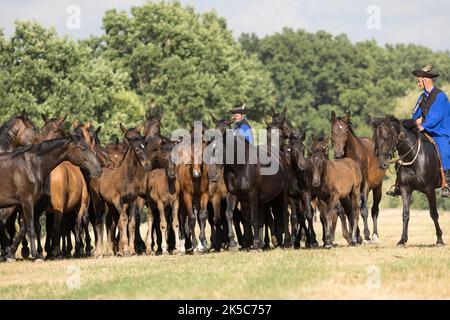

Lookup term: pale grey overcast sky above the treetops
[0,0,450,50]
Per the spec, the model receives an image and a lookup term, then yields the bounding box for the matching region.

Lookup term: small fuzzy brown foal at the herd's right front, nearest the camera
[309,142,362,248]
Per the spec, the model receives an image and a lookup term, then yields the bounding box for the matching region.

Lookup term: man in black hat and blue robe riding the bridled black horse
[387,64,450,197]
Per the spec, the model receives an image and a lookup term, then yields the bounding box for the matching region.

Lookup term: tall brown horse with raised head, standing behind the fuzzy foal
[331,111,386,243]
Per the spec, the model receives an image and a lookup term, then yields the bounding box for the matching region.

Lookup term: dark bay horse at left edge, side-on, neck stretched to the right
[0,136,101,259]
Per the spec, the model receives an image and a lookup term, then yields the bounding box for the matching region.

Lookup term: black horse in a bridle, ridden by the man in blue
[372,116,444,246]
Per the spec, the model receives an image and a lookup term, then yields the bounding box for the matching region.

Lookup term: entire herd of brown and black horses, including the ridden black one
[0,109,443,261]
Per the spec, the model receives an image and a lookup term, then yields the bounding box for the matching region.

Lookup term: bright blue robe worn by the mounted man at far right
[413,87,450,170]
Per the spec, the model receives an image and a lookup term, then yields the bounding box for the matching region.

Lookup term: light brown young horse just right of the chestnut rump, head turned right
[90,125,151,258]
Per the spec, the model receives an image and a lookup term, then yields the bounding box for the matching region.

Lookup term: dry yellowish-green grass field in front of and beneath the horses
[0,209,450,299]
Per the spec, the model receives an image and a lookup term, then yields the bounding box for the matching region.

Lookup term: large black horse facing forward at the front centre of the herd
[223,129,286,250]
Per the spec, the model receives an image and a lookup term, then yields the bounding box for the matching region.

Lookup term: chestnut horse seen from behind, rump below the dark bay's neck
[38,115,89,258]
